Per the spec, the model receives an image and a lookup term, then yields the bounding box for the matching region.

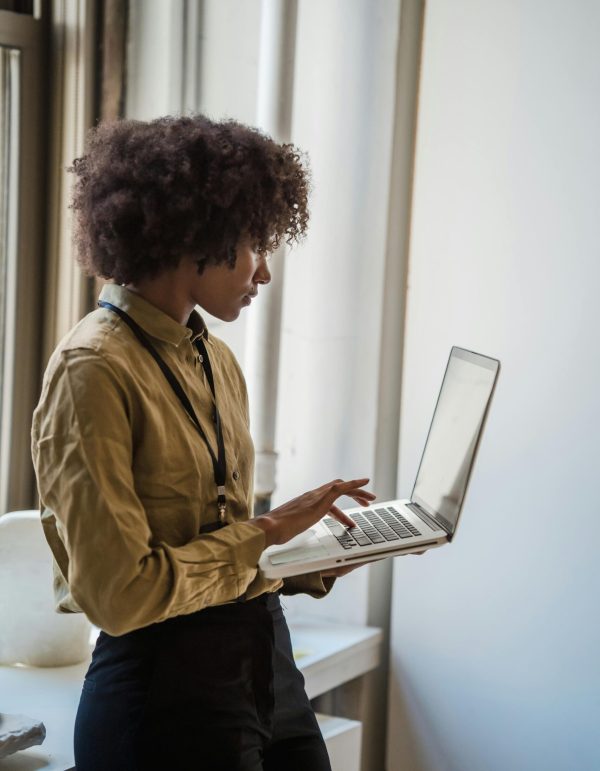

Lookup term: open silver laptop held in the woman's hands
[259,347,500,578]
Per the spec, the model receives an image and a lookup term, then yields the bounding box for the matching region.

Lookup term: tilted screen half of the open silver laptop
[411,348,500,534]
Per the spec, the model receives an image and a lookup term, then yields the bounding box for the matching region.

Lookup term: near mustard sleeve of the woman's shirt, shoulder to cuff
[33,351,265,635]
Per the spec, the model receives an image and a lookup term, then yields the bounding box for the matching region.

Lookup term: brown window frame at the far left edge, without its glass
[0,11,46,515]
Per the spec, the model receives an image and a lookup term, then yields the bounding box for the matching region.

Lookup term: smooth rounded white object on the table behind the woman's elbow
[0,511,91,668]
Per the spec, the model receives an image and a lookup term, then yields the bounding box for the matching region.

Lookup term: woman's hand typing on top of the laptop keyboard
[252,478,377,546]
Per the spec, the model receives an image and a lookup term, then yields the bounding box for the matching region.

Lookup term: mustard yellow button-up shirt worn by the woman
[32,284,332,635]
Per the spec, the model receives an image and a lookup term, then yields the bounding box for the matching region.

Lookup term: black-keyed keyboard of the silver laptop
[323,506,421,549]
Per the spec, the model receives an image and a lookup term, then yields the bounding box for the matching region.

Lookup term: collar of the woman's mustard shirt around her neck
[100,284,208,346]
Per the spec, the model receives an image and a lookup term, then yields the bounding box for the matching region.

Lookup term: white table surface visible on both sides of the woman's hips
[0,618,382,771]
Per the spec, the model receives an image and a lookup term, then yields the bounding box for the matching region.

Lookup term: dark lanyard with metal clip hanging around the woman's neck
[98,300,227,525]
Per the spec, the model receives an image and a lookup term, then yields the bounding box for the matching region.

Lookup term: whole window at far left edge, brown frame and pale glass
[0,9,45,515]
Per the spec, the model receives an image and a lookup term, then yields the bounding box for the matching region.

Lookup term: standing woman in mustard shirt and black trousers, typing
[33,116,374,771]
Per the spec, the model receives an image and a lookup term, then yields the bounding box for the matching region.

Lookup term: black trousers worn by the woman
[75,594,331,771]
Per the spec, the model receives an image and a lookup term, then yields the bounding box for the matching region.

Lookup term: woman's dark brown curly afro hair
[69,115,309,284]
